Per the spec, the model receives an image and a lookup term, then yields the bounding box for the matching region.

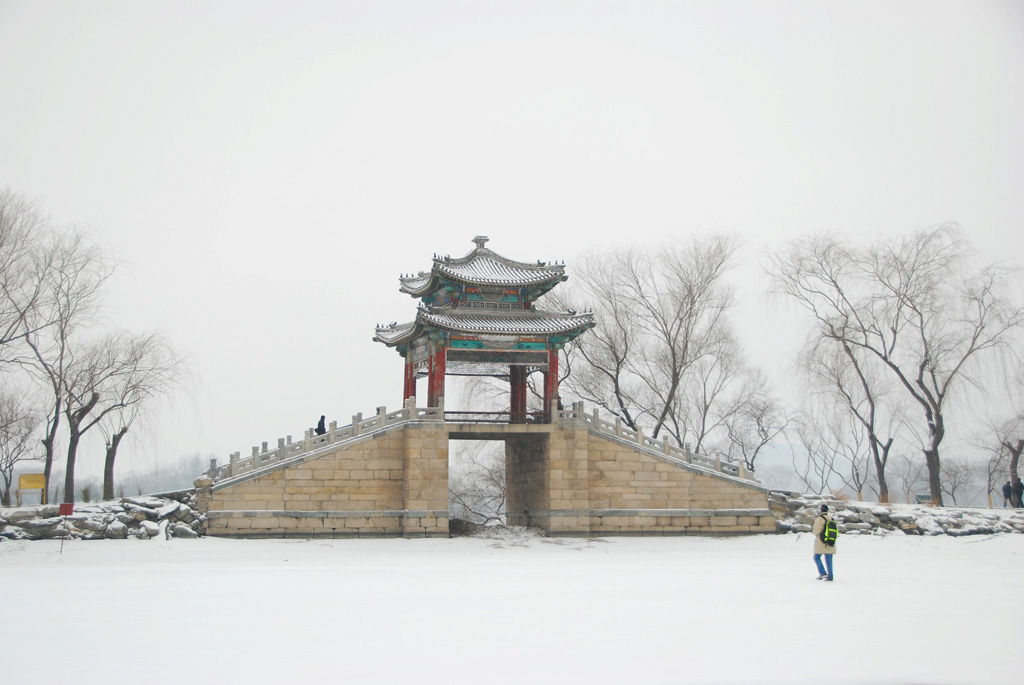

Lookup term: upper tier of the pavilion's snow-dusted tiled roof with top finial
[399,236,566,297]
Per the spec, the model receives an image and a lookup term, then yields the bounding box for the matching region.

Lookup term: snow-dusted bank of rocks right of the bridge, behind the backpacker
[768,490,1024,536]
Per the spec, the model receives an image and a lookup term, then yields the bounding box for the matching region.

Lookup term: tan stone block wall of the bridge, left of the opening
[204,423,447,538]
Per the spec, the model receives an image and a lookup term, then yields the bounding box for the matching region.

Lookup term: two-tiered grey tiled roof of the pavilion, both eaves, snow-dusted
[374,236,594,347]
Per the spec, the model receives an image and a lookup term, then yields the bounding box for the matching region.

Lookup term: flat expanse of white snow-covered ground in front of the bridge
[0,531,1024,685]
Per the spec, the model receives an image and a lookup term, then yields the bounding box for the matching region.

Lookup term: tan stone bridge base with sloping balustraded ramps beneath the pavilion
[196,397,775,538]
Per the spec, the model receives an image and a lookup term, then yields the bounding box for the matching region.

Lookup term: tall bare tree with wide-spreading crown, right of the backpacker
[771,224,1024,505]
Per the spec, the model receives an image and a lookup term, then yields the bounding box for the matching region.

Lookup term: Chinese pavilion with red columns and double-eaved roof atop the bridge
[374,236,594,423]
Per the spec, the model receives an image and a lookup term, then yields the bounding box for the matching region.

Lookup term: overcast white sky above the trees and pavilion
[0,0,1024,481]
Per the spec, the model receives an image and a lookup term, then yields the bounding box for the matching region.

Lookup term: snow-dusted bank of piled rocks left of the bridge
[0,490,206,541]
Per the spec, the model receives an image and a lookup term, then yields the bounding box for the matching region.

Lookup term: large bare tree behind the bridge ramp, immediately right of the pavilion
[558,237,736,441]
